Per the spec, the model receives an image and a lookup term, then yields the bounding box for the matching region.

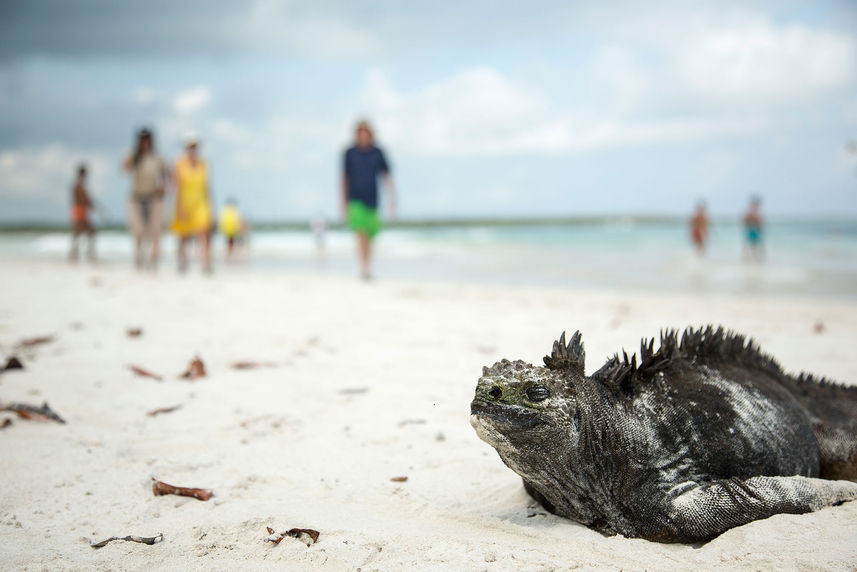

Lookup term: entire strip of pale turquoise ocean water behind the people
[0,219,857,298]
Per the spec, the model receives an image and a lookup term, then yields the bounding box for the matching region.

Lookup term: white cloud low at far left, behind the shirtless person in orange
[0,144,111,202]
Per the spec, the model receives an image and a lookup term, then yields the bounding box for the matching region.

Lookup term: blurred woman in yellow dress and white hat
[172,135,213,274]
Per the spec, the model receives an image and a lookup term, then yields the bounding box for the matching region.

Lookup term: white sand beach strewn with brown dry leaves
[0,260,857,570]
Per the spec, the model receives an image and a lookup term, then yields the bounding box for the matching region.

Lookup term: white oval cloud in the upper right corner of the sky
[676,21,857,100]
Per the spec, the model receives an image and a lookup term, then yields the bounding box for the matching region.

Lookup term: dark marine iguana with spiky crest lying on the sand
[471,326,857,542]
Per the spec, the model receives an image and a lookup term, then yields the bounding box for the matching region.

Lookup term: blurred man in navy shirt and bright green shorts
[342,121,396,280]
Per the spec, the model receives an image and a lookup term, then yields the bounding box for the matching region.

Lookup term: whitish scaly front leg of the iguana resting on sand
[644,476,857,542]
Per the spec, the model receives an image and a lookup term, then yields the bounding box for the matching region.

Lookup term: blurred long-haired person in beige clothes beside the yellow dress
[123,128,169,270]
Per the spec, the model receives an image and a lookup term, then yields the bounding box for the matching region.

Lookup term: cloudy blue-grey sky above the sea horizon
[0,0,857,222]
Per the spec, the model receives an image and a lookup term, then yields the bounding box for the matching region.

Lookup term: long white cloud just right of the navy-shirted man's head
[364,68,764,155]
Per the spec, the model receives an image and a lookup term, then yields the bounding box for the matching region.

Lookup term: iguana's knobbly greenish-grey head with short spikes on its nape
[470,333,584,456]
